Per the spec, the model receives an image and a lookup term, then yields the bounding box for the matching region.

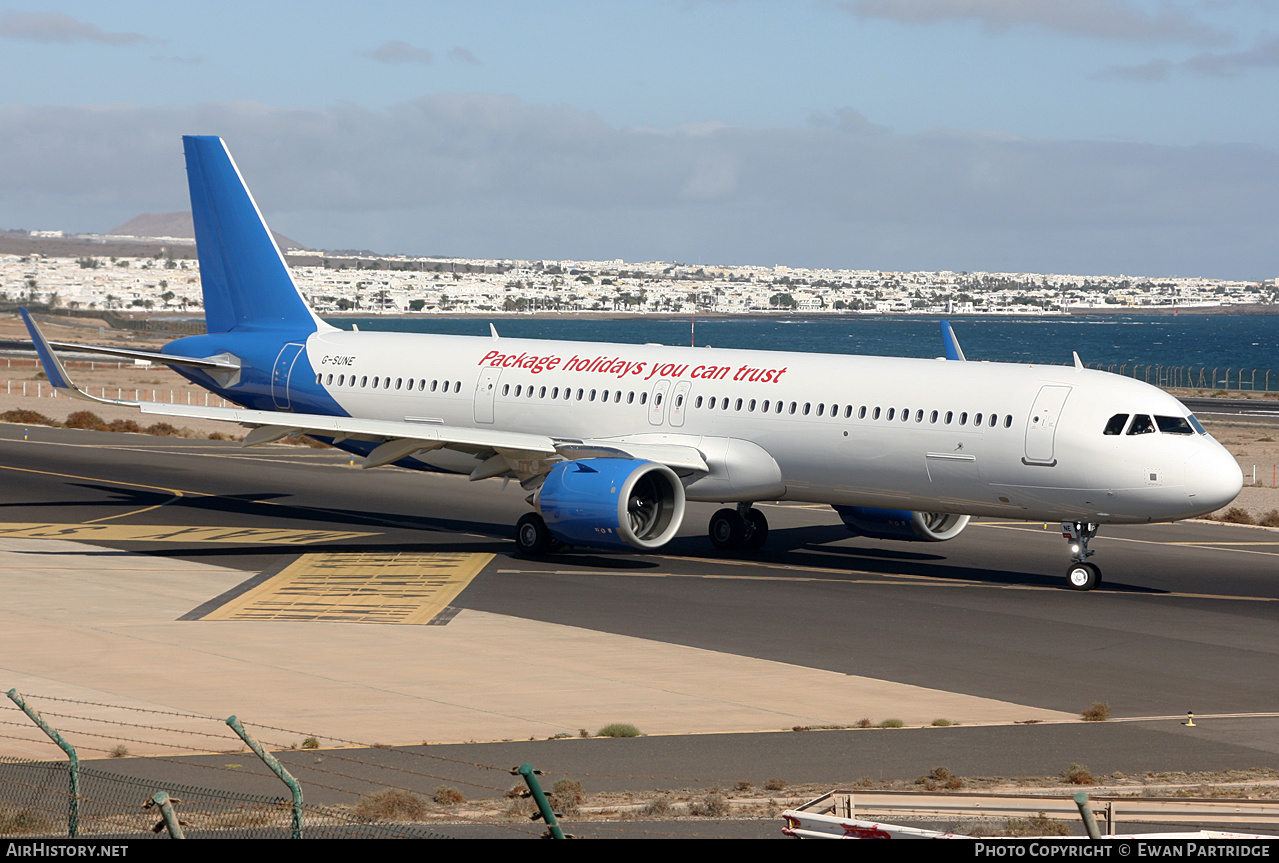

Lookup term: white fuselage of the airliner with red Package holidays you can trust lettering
[296,331,1241,523]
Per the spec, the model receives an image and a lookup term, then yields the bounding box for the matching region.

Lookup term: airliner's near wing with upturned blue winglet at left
[20,309,710,482]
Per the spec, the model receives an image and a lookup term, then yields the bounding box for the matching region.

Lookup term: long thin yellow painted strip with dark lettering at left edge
[0,522,380,545]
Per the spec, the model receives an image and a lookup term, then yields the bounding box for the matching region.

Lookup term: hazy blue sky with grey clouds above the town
[0,0,1279,279]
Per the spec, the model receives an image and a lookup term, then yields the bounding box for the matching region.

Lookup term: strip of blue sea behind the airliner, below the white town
[333,312,1279,375]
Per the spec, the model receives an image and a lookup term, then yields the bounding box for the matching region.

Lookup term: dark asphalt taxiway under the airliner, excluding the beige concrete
[0,426,1279,716]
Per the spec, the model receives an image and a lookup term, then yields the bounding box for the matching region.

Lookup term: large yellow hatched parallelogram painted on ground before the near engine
[202,552,494,624]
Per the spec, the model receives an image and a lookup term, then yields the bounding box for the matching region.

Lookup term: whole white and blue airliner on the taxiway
[22,136,1243,591]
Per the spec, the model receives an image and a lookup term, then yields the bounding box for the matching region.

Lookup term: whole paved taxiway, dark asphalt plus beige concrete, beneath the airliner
[0,426,1279,782]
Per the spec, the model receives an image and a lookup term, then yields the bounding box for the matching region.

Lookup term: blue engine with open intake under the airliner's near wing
[533,459,684,548]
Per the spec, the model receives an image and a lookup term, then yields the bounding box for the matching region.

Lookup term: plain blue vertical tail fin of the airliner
[182,136,327,335]
